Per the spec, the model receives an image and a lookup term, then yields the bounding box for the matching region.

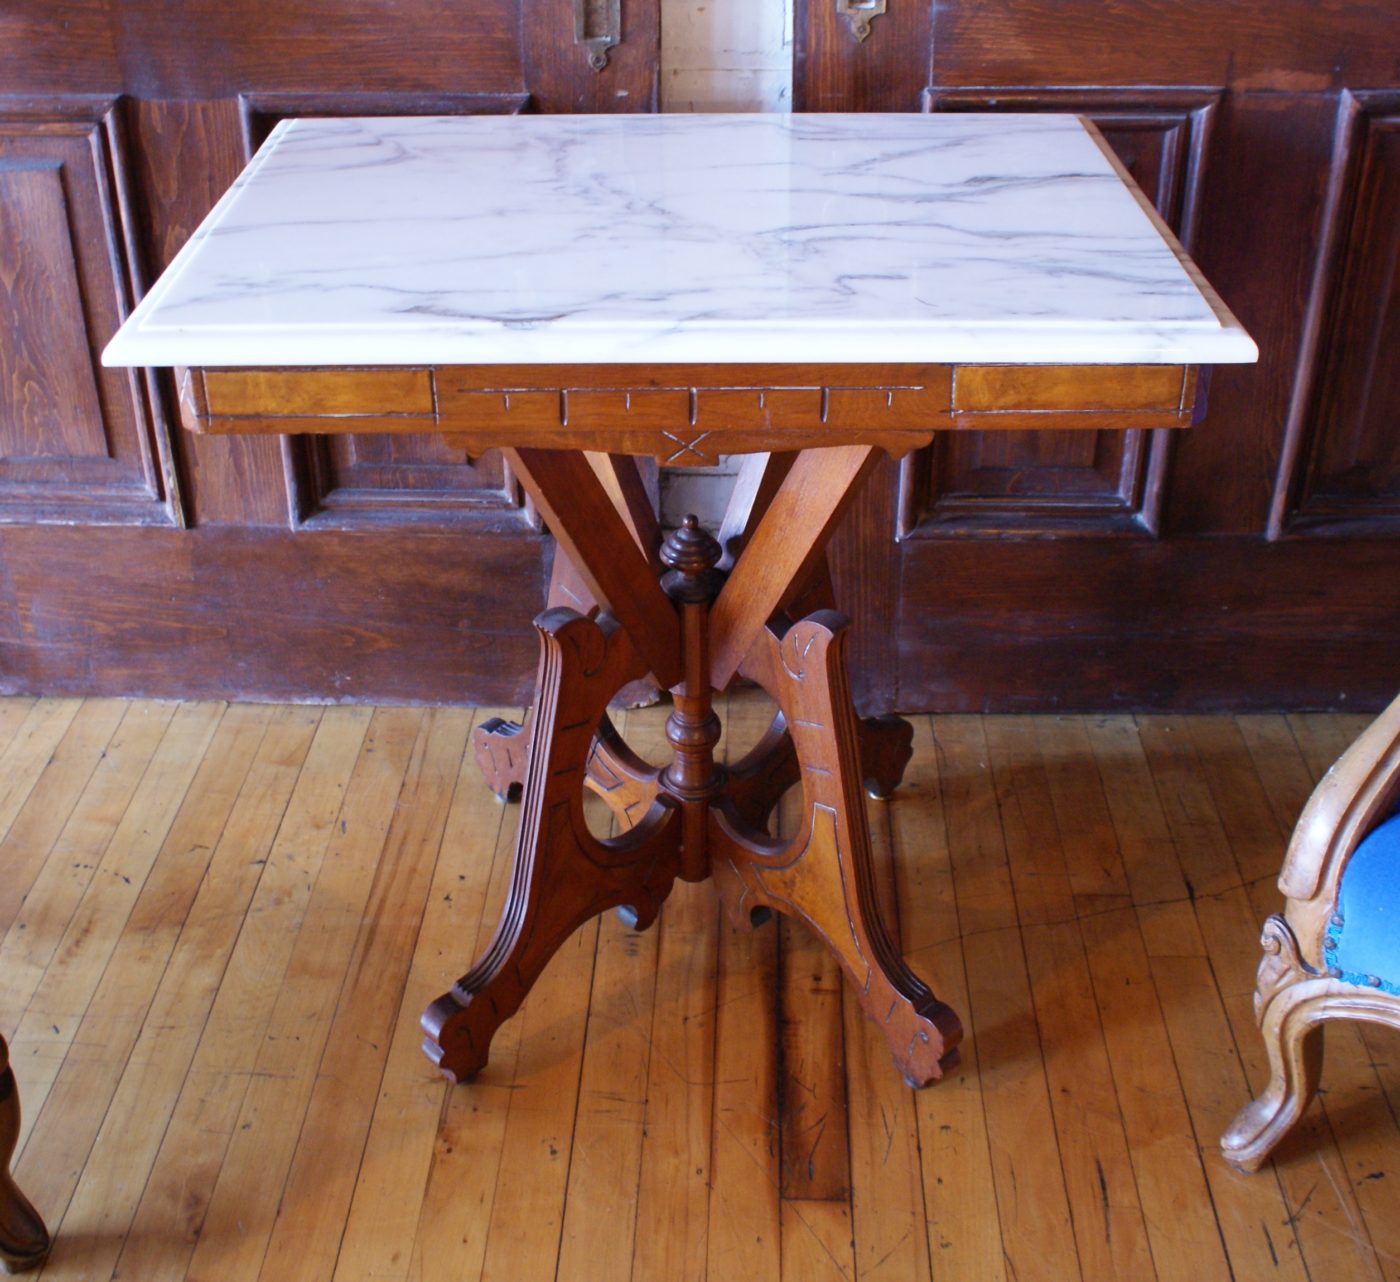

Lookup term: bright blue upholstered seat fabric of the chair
[1324,812,1400,995]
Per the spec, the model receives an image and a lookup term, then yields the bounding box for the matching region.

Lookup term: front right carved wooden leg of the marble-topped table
[711,610,962,1086]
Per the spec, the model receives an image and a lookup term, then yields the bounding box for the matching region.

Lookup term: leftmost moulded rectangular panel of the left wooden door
[0,98,181,525]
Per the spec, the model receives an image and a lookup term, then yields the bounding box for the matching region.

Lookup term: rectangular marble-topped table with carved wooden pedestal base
[105,115,1256,1102]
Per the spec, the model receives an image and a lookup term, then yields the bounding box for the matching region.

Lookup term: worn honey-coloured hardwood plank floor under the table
[0,696,1400,1282]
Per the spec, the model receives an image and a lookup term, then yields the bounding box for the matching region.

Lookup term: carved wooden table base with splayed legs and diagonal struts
[423,448,962,1086]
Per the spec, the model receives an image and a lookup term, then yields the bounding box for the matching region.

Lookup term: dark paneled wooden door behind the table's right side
[812,0,1400,711]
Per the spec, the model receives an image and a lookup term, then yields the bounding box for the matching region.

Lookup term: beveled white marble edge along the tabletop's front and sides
[102,112,1257,368]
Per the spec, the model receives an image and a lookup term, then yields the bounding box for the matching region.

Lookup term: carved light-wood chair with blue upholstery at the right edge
[1221,698,1400,1170]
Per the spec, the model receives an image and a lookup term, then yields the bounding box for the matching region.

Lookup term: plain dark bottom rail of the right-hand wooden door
[890,531,1400,712]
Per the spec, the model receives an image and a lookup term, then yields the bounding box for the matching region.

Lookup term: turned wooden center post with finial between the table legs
[661,515,724,882]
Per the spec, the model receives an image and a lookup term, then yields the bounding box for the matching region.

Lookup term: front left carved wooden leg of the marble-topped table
[423,609,680,1082]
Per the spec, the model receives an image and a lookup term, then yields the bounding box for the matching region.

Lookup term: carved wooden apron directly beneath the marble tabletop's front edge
[185,365,1194,467]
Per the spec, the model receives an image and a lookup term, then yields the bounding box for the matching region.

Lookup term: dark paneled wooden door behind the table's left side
[0,0,658,701]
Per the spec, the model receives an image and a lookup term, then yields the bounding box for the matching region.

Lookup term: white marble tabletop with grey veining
[104,115,1256,365]
